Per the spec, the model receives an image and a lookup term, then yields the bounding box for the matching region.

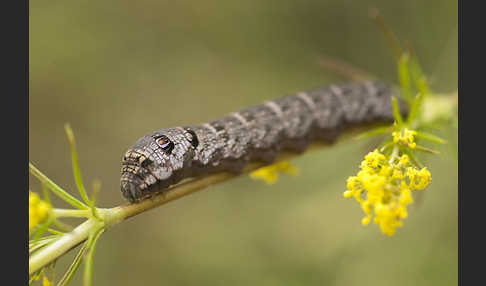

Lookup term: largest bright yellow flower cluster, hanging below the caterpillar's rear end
[344,150,431,236]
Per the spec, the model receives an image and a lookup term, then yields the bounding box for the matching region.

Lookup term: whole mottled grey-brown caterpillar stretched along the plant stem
[121,82,407,202]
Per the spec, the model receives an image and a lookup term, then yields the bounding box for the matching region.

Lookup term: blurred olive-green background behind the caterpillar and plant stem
[29,0,458,286]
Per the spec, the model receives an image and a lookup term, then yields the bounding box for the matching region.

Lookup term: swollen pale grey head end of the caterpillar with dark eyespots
[120,128,199,202]
